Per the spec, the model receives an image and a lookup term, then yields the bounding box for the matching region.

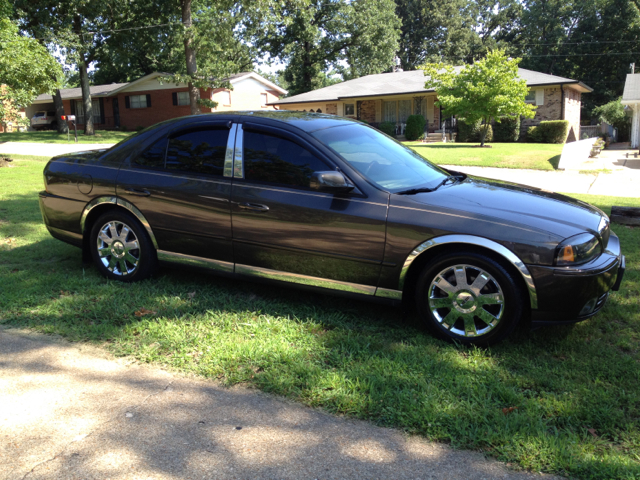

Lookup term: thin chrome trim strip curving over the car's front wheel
[398,235,538,309]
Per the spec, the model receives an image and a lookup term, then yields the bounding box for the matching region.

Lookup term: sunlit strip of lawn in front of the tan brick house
[403,142,563,170]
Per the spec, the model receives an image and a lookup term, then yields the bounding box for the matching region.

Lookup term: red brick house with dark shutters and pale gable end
[26,72,287,130]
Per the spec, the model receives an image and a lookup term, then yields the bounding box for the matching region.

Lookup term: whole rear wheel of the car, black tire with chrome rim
[89,210,158,282]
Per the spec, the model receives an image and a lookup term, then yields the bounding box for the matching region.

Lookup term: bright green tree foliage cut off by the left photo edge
[0,13,62,127]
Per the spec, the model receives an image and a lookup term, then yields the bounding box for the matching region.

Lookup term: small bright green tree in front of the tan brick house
[423,50,536,146]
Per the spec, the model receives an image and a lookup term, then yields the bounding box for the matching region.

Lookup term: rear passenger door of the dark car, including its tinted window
[117,122,233,271]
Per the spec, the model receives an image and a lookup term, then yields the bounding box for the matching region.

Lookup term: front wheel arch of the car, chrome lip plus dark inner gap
[398,235,538,310]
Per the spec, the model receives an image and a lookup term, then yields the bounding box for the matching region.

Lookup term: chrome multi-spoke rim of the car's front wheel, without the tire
[429,265,504,337]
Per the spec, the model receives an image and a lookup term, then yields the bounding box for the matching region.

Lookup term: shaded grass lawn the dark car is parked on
[0,155,640,480]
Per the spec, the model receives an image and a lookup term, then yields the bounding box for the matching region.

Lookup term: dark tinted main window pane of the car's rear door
[165,128,229,176]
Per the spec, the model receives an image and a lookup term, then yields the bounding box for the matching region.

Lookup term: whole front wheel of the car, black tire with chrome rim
[416,251,526,346]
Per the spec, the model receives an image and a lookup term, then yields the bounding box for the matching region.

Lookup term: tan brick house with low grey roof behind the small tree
[272,67,593,141]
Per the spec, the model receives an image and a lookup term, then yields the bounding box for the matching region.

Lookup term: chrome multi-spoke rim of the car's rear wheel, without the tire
[97,221,140,276]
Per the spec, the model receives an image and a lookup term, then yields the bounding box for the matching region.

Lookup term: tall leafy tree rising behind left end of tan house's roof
[252,0,400,95]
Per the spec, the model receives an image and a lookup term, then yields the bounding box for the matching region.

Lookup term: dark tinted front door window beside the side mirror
[243,130,332,188]
